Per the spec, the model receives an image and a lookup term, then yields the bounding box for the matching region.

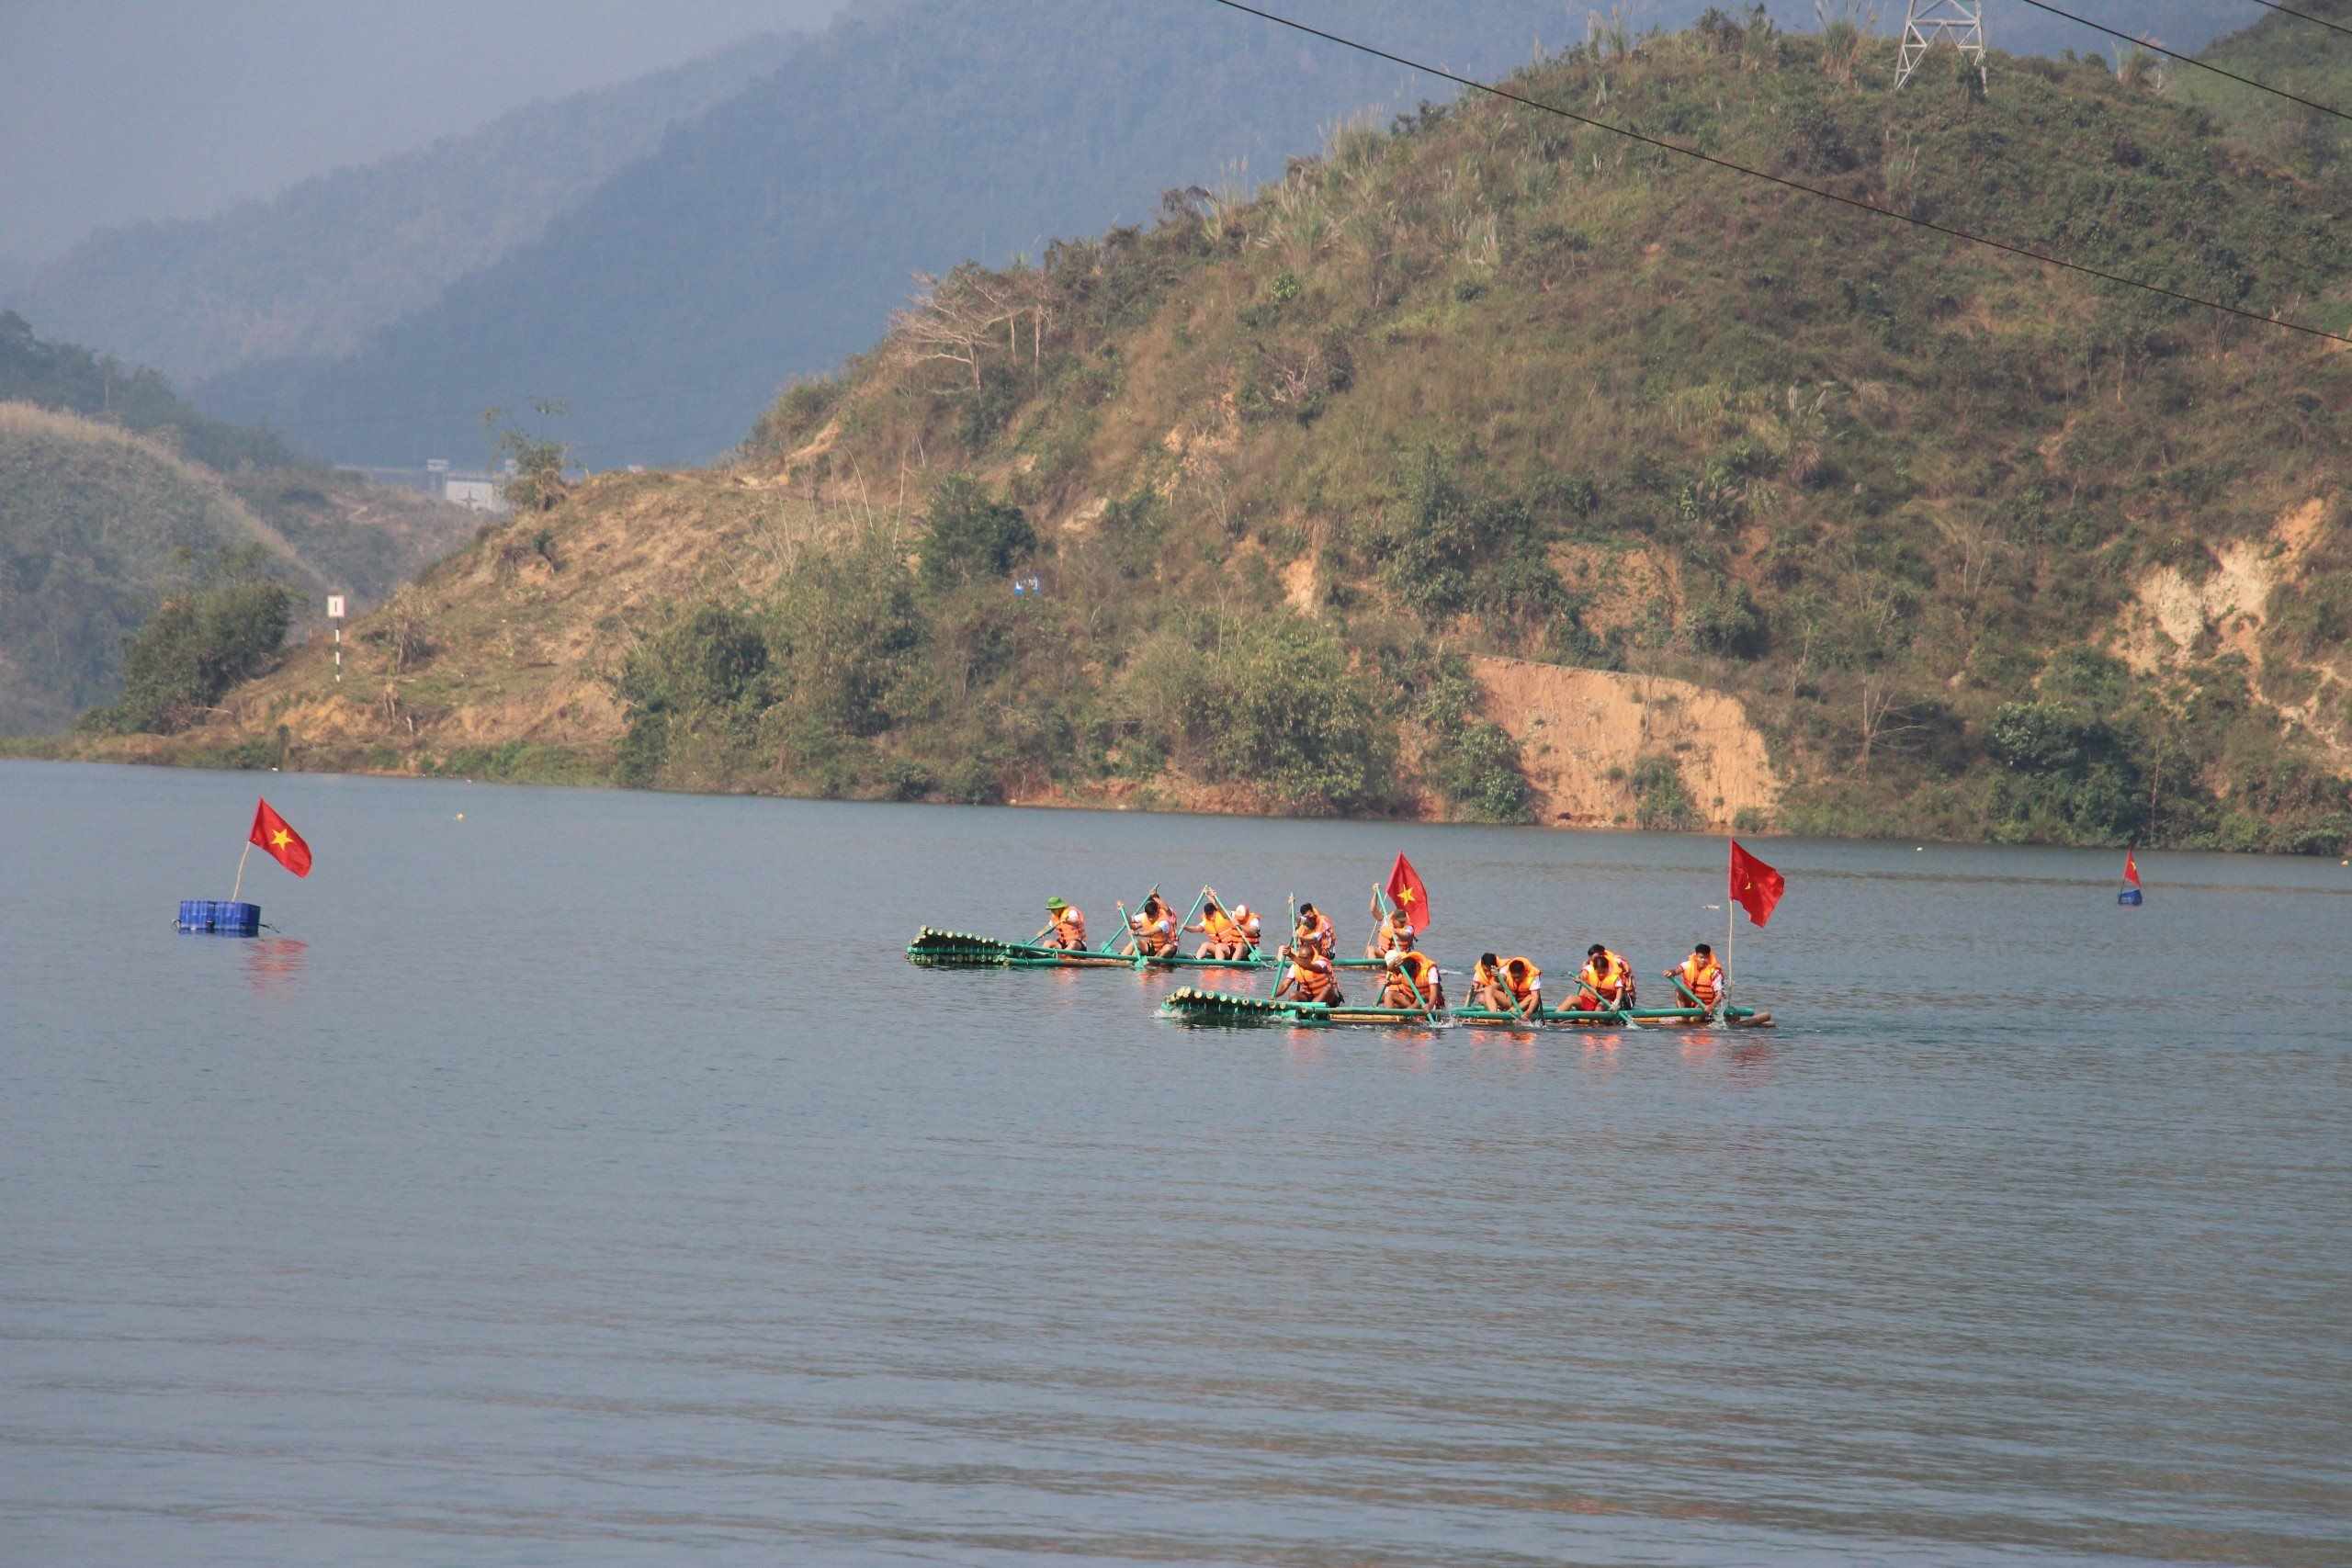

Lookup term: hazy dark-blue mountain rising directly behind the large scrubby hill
[200,0,2248,466]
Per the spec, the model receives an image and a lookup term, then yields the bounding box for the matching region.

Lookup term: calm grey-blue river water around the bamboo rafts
[0,764,2352,1565]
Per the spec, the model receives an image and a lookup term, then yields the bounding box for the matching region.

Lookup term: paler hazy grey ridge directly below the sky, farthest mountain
[0,35,795,383]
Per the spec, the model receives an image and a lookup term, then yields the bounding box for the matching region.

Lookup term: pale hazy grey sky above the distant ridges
[0,0,873,273]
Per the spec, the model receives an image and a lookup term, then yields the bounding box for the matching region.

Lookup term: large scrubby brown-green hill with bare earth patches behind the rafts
[133,18,2352,851]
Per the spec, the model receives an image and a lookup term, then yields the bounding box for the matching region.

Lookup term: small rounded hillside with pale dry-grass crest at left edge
[0,404,320,733]
